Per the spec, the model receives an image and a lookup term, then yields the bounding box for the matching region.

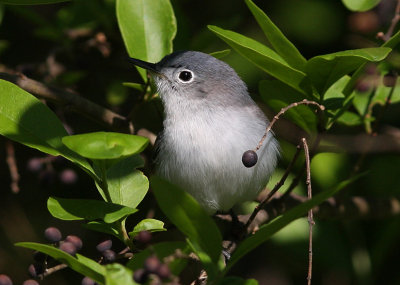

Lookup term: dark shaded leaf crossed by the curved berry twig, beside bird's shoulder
[259,80,317,132]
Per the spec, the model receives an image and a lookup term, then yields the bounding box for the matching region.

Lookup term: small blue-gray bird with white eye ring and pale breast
[131,51,278,214]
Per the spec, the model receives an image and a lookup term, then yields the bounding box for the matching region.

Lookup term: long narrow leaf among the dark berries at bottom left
[15,242,106,284]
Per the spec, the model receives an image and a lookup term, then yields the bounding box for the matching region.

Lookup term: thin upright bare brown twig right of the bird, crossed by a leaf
[301,138,315,285]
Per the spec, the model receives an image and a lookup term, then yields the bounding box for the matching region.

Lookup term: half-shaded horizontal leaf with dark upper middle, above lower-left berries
[47,197,137,223]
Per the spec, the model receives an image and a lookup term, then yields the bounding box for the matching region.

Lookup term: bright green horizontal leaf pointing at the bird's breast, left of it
[62,132,149,159]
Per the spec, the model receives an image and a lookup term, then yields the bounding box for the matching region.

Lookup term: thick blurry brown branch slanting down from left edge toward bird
[0,72,134,133]
